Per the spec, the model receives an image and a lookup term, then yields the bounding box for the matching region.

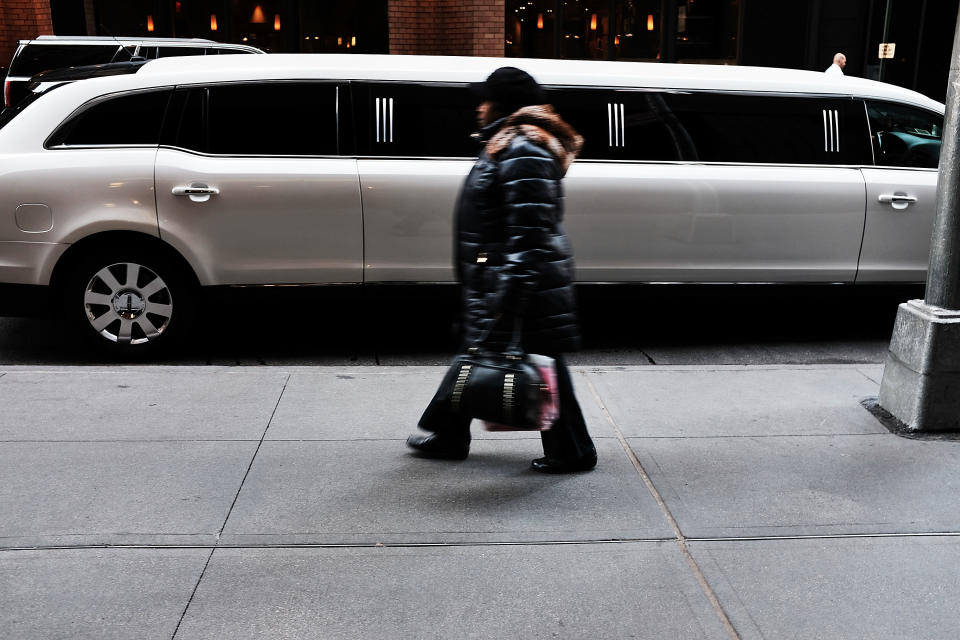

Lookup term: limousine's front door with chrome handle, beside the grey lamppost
[857,101,943,282]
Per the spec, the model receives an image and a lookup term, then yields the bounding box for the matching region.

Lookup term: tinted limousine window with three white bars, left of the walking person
[353,83,480,157]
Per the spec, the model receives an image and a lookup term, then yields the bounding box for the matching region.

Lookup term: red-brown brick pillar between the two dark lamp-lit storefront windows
[387,0,504,57]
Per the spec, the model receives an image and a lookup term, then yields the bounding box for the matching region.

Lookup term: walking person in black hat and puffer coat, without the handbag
[407,67,597,473]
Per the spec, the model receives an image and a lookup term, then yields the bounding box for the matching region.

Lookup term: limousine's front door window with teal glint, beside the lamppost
[867,101,943,169]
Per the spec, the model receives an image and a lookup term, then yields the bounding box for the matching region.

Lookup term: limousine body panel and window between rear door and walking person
[352,82,480,283]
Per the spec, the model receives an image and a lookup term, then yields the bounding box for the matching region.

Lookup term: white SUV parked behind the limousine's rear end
[3,36,263,107]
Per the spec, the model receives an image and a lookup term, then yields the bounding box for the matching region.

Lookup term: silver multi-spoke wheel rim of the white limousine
[83,262,173,344]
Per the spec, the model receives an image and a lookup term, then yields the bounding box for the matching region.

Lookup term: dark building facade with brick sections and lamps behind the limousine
[0,0,960,100]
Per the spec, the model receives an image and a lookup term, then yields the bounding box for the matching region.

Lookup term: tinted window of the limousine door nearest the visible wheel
[197,82,337,156]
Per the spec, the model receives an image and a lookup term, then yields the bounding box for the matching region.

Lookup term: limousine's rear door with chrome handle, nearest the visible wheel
[156,82,363,284]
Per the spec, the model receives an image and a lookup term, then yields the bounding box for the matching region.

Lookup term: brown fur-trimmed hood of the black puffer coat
[486,104,583,173]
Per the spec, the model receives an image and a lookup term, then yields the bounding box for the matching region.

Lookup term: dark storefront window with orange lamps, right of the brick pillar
[505,0,741,62]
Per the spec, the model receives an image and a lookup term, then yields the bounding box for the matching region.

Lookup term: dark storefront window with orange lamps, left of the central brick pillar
[88,0,389,53]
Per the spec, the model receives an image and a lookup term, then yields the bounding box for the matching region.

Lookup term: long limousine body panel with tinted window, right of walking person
[551,88,866,282]
